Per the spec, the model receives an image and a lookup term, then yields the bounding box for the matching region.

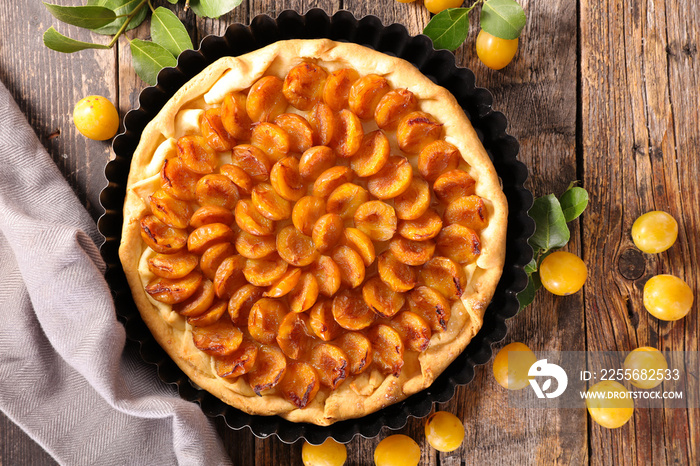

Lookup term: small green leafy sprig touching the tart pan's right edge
[518,182,588,310]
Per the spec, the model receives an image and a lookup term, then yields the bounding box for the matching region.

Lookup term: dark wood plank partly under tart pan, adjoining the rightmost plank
[448,1,587,464]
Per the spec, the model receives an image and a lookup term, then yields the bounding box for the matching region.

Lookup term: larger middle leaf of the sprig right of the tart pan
[528,194,571,252]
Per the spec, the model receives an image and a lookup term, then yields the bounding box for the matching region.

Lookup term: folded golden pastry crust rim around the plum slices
[119,39,508,425]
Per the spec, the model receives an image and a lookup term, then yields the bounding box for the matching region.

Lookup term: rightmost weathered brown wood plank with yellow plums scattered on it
[581,0,700,464]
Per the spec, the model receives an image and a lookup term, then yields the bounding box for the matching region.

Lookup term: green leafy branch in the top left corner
[44,0,242,84]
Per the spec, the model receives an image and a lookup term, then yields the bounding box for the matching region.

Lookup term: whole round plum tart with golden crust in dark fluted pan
[119,40,507,425]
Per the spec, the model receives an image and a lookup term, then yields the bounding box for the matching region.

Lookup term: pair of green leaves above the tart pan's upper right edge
[423,0,527,50]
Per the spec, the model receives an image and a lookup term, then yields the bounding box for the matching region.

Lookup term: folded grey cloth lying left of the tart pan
[0,79,230,466]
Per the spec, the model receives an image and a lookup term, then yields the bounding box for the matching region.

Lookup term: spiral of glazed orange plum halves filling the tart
[135,62,488,408]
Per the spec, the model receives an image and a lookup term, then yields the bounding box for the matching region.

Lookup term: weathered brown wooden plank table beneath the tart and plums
[0,0,700,465]
